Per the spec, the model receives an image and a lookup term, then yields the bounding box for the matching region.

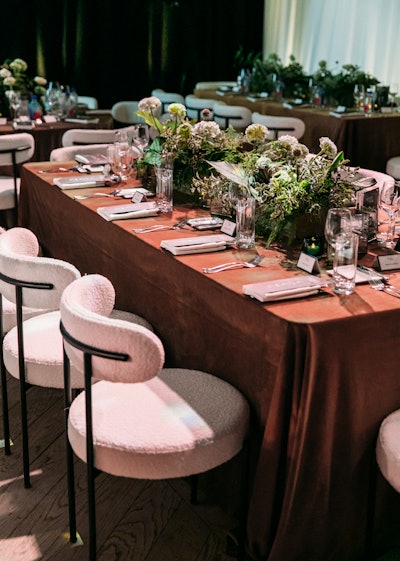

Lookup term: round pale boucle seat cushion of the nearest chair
[68,369,249,479]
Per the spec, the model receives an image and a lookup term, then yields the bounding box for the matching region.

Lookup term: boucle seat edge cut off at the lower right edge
[376,409,400,493]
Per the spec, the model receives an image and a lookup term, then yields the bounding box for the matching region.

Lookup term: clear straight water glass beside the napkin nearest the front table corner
[332,234,359,295]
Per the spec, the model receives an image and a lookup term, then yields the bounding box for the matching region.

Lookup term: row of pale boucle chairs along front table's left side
[0,227,249,561]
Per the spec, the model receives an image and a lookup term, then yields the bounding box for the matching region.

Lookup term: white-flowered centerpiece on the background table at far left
[0,58,47,117]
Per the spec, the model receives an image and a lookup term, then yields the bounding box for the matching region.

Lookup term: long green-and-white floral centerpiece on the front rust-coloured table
[138,97,354,243]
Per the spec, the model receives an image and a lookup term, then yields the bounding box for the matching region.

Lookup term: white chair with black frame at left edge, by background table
[0,132,35,225]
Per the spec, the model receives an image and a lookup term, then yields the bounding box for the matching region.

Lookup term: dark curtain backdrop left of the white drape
[0,0,264,108]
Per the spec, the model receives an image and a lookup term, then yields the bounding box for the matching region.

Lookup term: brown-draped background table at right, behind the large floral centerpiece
[194,90,400,172]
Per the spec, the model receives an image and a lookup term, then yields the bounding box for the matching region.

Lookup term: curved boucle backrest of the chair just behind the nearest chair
[0,227,80,310]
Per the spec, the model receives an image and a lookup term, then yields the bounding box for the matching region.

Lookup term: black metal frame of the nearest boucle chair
[60,322,249,561]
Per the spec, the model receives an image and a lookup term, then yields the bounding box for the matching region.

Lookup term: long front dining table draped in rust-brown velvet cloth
[19,163,400,561]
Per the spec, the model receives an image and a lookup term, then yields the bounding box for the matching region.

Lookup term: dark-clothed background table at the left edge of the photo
[0,114,114,162]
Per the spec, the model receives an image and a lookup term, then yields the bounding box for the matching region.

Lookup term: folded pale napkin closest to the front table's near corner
[243,275,327,302]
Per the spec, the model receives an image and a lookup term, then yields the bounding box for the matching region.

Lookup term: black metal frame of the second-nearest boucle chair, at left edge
[0,272,54,489]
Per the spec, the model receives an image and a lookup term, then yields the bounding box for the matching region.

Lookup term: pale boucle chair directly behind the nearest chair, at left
[0,228,152,487]
